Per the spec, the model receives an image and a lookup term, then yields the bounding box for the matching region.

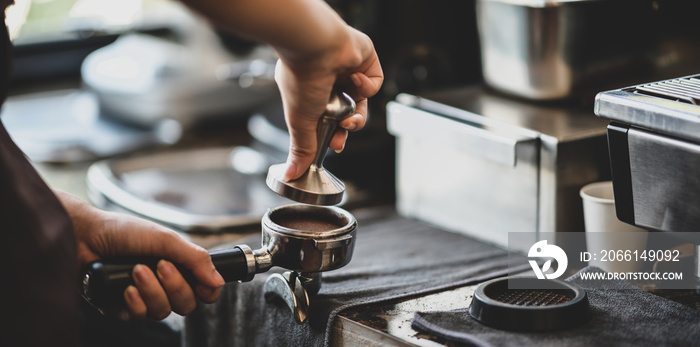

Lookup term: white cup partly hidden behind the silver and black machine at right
[580,181,648,272]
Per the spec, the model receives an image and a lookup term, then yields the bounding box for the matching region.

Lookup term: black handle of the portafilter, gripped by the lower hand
[82,246,255,309]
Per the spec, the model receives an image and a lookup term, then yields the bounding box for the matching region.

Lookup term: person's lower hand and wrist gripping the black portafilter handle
[56,191,224,320]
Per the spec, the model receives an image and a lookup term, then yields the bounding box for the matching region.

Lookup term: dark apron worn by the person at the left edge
[0,17,80,346]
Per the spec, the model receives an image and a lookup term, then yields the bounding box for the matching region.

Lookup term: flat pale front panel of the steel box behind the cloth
[387,98,539,250]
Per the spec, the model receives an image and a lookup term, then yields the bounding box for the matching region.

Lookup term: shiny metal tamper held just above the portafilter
[265,91,356,205]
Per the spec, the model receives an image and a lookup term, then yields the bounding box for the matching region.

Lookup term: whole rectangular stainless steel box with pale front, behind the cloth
[387,86,609,252]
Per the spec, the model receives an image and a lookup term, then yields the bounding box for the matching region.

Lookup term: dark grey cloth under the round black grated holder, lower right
[412,267,700,347]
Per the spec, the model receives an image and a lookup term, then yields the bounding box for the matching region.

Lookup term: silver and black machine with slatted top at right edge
[595,75,700,294]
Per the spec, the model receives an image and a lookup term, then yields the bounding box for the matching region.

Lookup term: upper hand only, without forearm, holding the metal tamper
[275,25,384,180]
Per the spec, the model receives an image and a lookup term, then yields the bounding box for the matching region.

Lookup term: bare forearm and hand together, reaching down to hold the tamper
[175,0,384,179]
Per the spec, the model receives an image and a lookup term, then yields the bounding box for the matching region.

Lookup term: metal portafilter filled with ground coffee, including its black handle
[82,204,357,323]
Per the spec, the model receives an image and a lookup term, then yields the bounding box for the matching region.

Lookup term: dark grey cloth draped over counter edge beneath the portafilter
[183,208,529,346]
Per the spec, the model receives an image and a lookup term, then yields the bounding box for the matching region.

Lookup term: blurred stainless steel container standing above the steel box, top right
[476,0,698,100]
